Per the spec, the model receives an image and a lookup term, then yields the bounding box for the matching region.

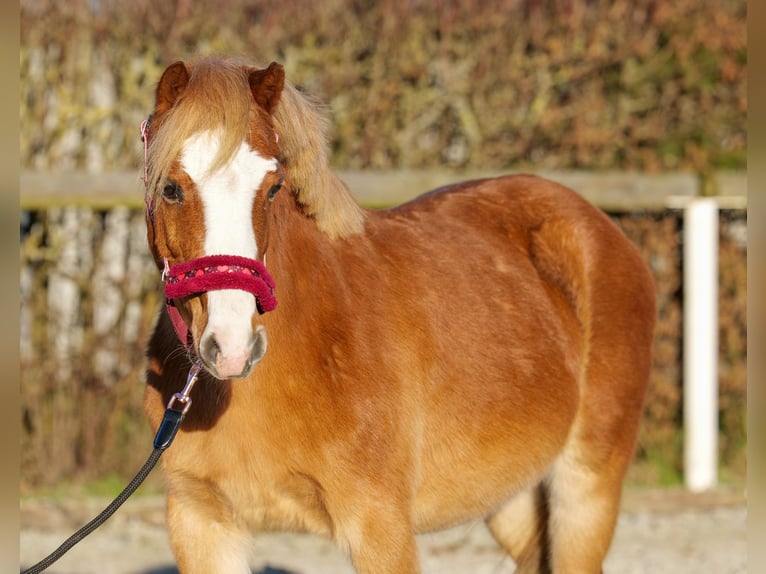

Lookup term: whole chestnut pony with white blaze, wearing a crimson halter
[144,58,655,574]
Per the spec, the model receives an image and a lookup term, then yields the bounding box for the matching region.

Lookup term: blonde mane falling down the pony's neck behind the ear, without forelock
[274,82,365,238]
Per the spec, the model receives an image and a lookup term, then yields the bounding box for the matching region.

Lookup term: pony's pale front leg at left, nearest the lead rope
[167,494,252,574]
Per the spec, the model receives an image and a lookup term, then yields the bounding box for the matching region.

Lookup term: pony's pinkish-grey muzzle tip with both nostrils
[199,325,267,379]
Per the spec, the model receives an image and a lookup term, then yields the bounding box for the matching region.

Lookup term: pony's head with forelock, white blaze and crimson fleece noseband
[144,60,285,379]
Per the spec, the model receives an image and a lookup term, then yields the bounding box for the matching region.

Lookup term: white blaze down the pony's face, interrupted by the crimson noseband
[181,132,277,372]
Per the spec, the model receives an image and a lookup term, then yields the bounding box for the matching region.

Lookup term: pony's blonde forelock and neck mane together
[147,58,365,238]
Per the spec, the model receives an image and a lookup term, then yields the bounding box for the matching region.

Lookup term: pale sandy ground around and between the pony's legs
[20,489,747,574]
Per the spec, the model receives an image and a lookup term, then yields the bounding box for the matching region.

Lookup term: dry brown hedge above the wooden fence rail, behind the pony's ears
[21,0,747,172]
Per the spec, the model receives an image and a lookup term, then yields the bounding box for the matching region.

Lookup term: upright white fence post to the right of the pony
[683,198,718,492]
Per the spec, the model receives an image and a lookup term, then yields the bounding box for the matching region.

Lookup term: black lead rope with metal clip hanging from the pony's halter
[21,360,200,574]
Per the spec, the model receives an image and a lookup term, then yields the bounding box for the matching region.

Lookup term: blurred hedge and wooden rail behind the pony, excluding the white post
[20,0,747,494]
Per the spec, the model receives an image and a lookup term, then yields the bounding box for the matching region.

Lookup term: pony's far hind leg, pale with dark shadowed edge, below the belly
[487,484,551,574]
